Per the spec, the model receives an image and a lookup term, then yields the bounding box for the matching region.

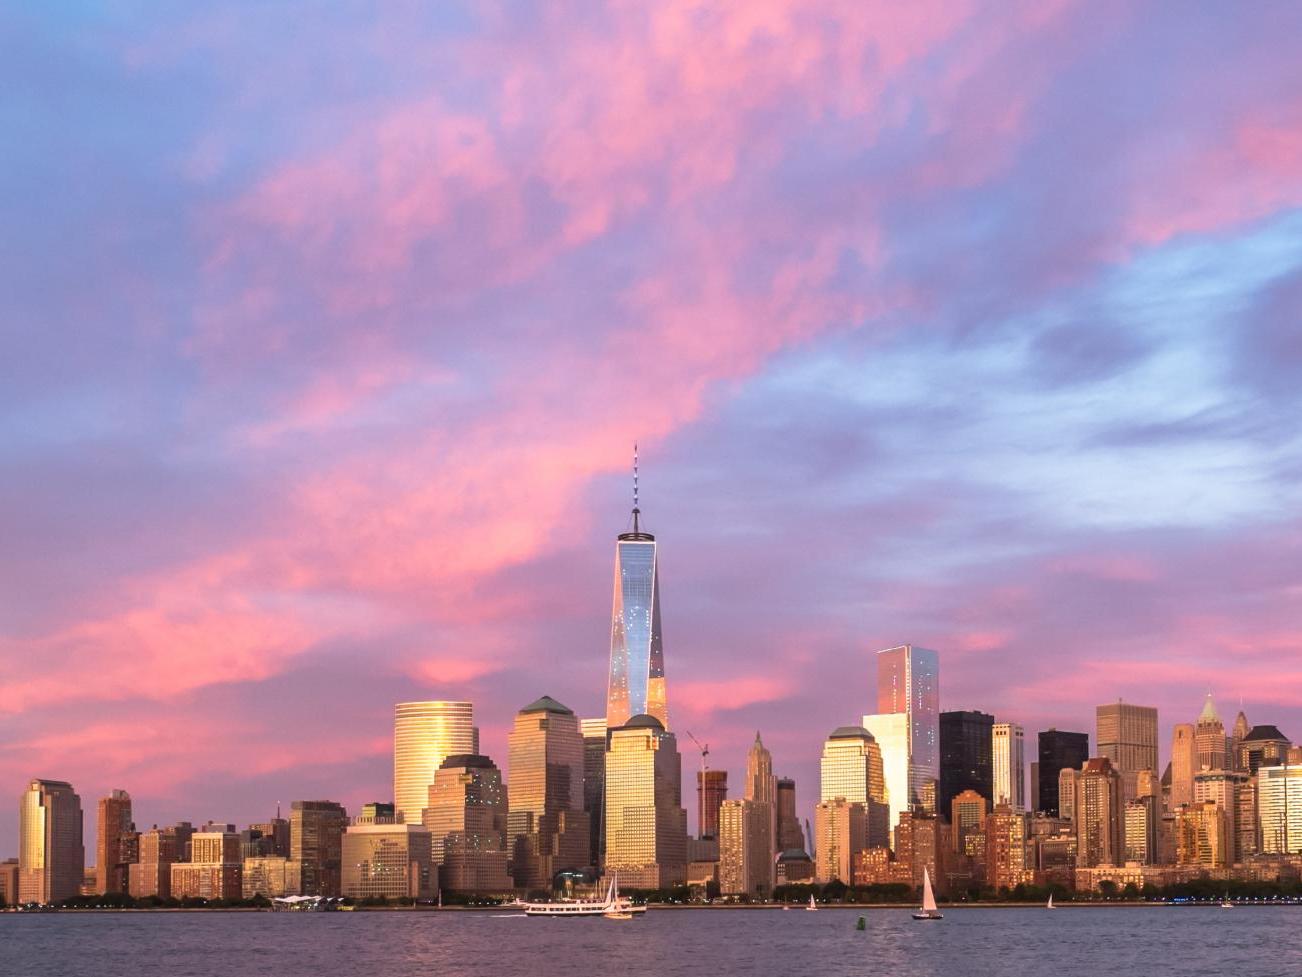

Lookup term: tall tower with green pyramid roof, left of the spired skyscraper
[506,696,590,890]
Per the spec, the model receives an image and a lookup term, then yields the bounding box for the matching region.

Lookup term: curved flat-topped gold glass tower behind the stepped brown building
[393,702,479,825]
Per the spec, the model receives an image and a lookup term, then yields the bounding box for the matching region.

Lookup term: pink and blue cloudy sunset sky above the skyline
[0,0,1302,844]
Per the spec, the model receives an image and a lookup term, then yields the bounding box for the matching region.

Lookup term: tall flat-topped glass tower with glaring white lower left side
[863,645,940,827]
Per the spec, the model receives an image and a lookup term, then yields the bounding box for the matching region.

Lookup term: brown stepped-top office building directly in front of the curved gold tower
[422,753,513,894]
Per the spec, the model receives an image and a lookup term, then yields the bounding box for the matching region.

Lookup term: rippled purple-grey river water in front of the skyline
[0,907,1302,977]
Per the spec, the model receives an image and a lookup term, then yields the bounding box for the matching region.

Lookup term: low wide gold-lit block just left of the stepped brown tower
[342,819,436,899]
